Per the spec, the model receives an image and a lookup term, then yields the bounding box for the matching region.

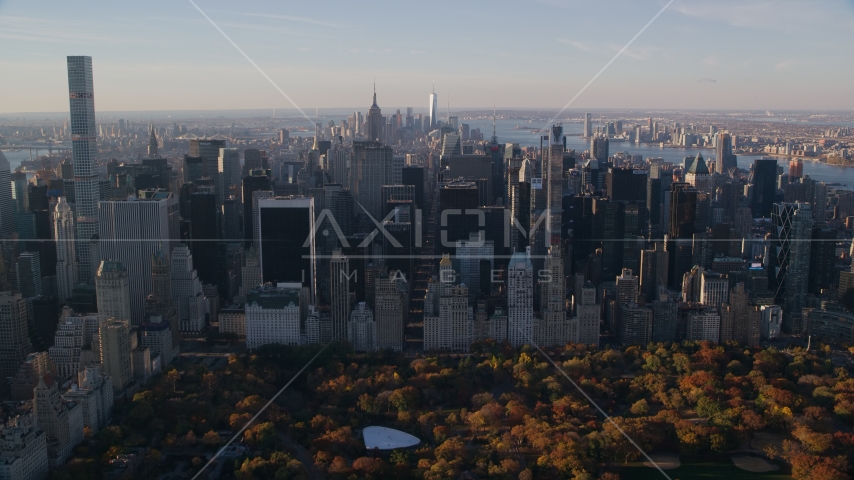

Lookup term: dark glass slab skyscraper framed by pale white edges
[258,197,316,299]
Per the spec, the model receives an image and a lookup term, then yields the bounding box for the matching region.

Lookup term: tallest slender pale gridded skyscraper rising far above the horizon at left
[68,57,100,282]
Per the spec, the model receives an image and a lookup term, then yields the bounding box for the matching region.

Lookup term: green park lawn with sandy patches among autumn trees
[619,455,792,480]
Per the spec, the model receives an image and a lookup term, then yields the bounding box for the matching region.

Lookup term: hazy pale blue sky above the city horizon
[0,0,854,113]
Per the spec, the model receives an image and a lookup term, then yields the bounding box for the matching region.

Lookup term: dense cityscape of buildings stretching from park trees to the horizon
[0,56,854,479]
